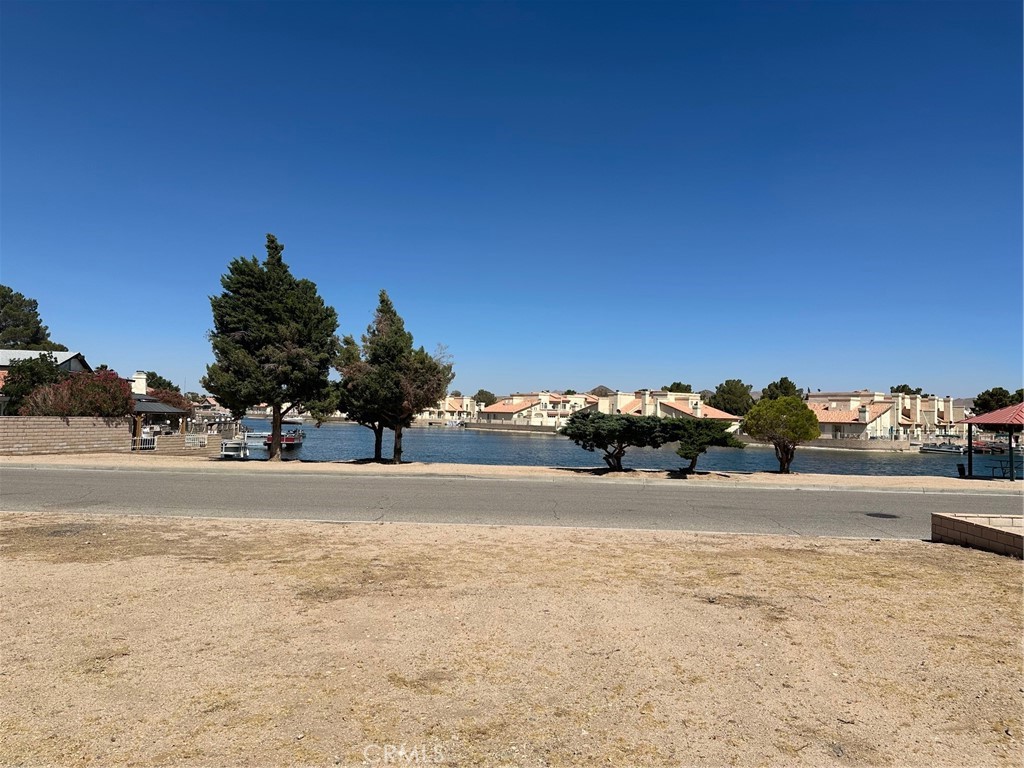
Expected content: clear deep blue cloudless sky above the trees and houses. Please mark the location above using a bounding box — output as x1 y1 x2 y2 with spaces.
0 0 1024 396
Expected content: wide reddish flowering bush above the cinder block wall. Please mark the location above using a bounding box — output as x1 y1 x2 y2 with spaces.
18 371 134 418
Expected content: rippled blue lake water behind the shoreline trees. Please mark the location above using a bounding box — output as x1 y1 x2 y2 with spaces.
244 419 1005 477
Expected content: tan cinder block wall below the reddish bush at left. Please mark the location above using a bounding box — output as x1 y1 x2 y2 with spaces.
0 416 131 456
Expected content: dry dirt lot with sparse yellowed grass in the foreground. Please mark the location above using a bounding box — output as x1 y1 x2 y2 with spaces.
0 514 1024 766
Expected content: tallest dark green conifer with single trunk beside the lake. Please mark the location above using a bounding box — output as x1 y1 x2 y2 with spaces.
202 234 338 461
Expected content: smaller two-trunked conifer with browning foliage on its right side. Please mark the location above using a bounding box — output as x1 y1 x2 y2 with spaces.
338 291 455 464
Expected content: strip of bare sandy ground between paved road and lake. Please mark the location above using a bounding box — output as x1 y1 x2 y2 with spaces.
0 453 1024 497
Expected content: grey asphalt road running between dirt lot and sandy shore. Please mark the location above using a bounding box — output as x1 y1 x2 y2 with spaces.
0 467 1021 539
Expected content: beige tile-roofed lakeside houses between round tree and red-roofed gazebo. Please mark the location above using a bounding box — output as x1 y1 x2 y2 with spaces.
807 389 966 440
